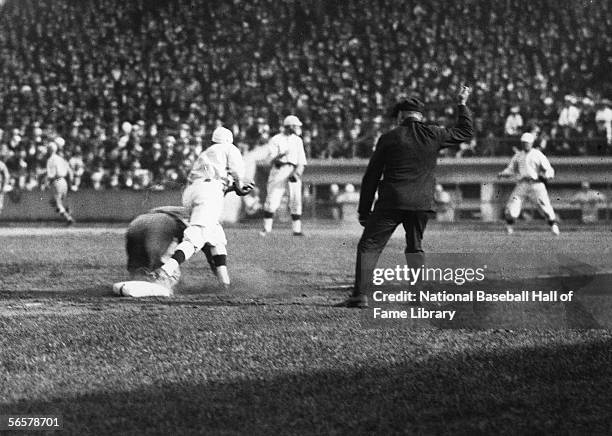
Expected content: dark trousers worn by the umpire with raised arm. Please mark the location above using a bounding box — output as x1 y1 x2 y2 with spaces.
353 208 430 296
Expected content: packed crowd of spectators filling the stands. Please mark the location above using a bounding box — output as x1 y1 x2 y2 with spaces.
0 0 612 189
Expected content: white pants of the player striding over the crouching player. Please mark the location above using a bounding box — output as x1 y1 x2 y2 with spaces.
179 179 227 255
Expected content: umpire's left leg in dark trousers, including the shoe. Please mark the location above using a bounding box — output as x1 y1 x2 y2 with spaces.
340 209 401 307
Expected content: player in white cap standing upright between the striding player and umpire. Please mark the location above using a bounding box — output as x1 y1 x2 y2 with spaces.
260 115 306 236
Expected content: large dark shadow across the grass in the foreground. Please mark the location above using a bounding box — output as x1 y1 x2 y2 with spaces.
1 334 612 435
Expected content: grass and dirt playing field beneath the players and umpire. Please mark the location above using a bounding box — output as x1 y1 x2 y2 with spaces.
0 224 612 435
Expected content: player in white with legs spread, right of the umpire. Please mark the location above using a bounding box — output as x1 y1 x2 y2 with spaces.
499 133 559 235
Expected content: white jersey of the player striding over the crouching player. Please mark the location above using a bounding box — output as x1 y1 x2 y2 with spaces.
189 143 245 182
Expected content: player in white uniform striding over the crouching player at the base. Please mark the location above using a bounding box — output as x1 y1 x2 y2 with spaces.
154 127 253 289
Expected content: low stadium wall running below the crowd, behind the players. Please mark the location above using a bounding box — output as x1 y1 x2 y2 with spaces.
0 157 612 222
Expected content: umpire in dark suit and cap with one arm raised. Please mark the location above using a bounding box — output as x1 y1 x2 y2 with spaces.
337 86 474 308
